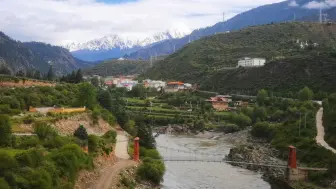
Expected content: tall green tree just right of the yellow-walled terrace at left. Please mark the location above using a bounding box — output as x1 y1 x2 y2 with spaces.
77 82 97 109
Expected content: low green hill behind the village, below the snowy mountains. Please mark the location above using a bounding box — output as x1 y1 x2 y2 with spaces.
84 60 154 76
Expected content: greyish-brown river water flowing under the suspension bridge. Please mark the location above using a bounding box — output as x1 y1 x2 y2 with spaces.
156 135 271 189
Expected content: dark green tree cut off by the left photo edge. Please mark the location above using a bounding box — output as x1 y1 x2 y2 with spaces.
0 115 12 147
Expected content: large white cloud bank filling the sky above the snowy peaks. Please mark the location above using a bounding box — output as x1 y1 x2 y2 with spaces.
0 0 282 44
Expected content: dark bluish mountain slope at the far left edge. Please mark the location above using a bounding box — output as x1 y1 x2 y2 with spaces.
0 32 90 75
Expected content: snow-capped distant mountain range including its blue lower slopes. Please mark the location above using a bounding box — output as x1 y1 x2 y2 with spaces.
65 29 190 61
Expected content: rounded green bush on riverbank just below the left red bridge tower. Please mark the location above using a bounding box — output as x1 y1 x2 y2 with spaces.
137 158 165 185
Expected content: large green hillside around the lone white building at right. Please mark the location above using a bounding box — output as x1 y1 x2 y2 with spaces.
144 22 336 94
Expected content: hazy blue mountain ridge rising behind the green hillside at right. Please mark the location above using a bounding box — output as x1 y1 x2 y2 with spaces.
125 0 336 59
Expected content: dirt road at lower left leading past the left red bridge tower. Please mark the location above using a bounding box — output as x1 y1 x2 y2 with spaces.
92 133 136 189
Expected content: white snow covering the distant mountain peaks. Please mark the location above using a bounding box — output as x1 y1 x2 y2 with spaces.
64 29 190 51
